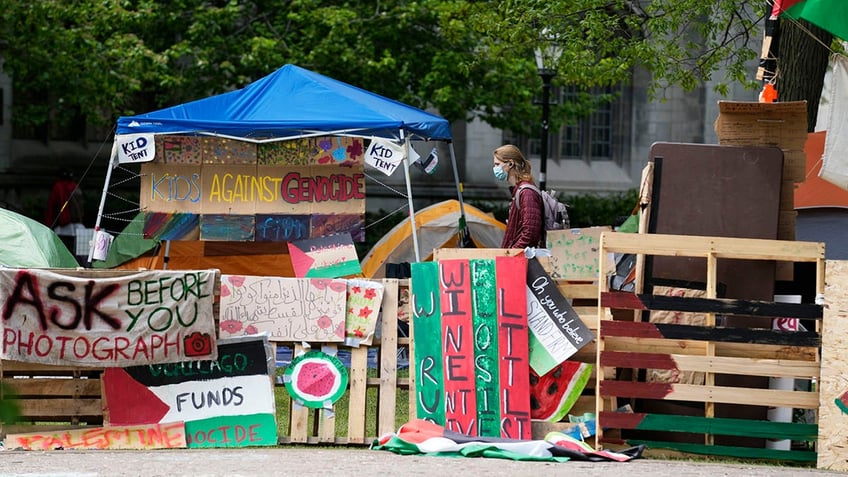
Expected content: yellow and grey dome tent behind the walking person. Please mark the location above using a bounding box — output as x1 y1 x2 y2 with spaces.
362 200 506 278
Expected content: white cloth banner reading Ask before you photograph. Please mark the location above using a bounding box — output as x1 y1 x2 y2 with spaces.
0 268 217 367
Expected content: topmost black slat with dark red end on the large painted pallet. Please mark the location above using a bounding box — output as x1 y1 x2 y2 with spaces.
601 292 822 320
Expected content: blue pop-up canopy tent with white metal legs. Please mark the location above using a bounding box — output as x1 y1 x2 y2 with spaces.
94 65 467 262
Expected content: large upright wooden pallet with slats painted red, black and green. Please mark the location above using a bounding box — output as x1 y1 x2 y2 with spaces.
596 233 825 462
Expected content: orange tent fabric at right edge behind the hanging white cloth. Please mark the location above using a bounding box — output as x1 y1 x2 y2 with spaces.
795 131 848 209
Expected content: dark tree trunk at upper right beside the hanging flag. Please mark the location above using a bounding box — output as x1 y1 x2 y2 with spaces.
777 19 833 132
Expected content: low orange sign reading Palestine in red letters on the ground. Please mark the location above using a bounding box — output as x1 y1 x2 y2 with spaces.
4 422 186 451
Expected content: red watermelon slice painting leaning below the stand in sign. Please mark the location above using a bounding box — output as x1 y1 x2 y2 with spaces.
530 360 592 422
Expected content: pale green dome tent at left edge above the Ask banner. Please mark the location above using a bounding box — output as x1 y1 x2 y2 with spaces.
0 209 79 268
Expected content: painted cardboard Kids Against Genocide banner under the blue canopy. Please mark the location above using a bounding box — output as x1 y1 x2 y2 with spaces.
140 136 365 241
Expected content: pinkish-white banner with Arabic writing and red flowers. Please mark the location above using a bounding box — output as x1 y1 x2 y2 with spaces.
220 275 347 342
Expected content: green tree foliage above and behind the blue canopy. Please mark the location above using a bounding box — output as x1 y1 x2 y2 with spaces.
0 0 764 133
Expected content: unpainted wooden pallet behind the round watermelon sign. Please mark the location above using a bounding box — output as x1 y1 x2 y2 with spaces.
277 278 414 445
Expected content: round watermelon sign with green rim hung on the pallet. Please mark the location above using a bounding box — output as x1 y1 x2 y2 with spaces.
283 351 349 409
